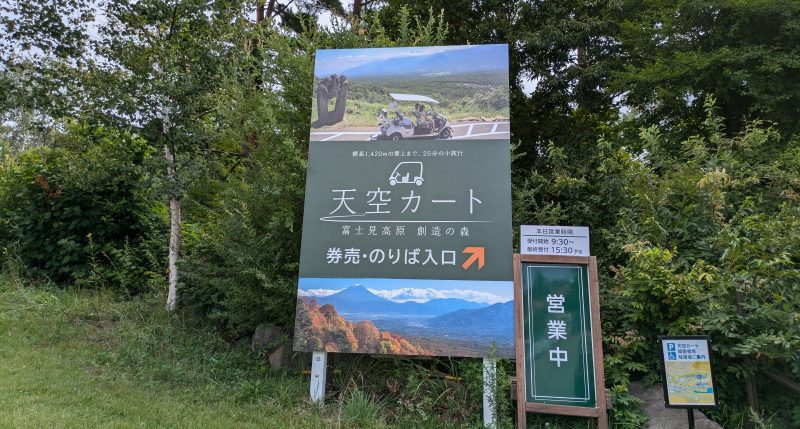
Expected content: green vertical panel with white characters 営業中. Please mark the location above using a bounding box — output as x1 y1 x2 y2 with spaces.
522 263 597 408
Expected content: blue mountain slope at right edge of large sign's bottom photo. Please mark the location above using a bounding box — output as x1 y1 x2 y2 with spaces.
426 301 514 337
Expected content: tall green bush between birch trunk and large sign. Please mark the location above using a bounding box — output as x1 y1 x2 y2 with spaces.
179 32 312 337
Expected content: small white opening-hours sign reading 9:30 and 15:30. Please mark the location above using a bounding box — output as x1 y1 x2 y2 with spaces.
519 225 590 256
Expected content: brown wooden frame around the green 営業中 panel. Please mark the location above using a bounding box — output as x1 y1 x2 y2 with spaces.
514 254 608 429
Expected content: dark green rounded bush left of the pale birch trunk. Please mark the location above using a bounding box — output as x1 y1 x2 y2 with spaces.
0 124 164 293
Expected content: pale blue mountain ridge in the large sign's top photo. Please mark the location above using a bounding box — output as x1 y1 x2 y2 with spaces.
342 45 508 78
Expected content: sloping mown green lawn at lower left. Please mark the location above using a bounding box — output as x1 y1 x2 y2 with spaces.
0 275 349 428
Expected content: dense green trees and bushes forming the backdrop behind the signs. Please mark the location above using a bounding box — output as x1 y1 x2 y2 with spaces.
0 0 800 428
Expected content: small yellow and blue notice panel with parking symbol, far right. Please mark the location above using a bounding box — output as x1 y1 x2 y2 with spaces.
658 335 717 408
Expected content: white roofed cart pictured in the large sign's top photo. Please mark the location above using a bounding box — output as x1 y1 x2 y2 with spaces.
372 94 453 141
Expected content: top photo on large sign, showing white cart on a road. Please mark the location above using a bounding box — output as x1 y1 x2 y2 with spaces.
311 45 510 141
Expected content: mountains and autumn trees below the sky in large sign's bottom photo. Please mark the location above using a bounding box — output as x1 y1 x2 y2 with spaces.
296 284 514 357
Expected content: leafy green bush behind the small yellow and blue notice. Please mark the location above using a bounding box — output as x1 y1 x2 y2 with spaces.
604 100 800 427
